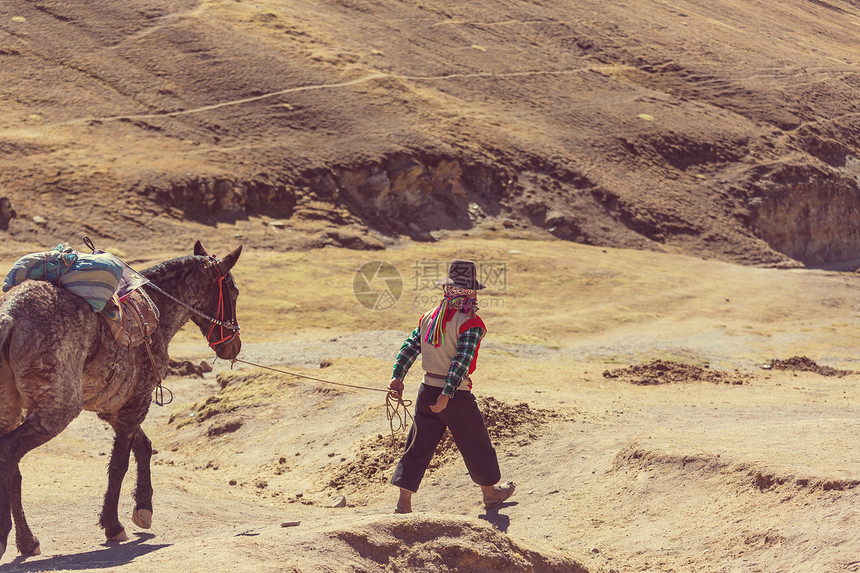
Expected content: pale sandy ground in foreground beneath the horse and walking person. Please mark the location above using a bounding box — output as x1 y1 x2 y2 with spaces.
2 318 860 573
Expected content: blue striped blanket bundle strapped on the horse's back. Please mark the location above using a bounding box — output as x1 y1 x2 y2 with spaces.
3 245 124 312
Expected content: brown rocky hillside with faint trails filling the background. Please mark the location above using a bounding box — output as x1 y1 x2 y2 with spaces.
0 0 860 266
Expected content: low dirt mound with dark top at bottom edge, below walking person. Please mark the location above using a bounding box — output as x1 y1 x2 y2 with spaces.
320 515 588 573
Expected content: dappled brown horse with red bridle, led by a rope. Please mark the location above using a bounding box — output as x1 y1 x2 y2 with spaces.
0 241 242 556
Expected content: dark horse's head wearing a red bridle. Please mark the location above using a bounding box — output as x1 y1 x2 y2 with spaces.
192 241 242 360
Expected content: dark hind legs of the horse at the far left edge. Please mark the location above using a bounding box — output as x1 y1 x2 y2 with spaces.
0 407 80 556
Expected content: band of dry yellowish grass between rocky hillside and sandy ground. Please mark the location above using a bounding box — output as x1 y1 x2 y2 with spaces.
4 238 860 363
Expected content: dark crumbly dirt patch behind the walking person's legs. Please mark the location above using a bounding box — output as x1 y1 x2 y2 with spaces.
329 397 559 490
